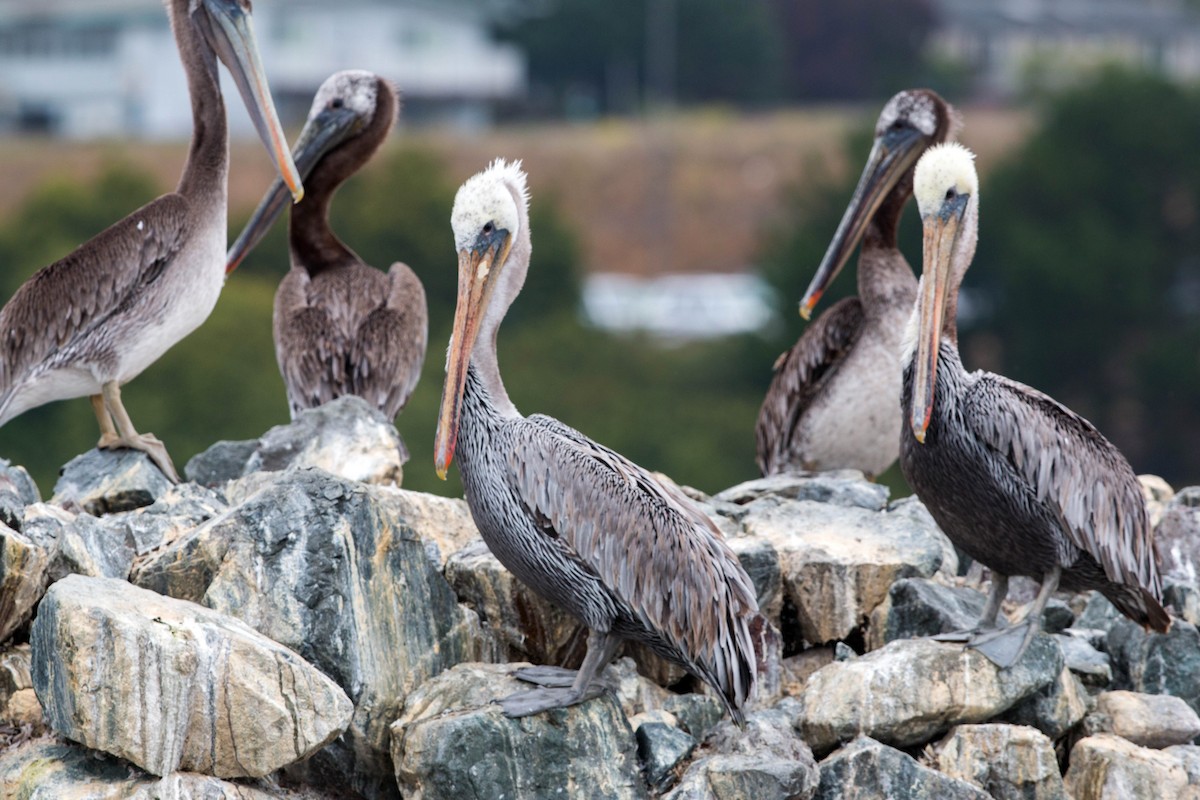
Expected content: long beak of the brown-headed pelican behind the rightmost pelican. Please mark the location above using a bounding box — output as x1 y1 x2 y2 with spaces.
800 127 925 319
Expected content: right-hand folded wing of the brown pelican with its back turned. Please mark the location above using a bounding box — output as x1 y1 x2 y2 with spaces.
350 263 430 419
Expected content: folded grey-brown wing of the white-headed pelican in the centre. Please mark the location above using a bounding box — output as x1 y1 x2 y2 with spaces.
509 415 758 705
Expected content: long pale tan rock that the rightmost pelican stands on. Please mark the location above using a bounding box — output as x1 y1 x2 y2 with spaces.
800 634 1062 753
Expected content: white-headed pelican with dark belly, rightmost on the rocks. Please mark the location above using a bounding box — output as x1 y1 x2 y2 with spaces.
900 144 1170 666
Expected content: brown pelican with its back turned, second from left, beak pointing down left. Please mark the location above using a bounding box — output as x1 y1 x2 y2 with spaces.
227 70 428 420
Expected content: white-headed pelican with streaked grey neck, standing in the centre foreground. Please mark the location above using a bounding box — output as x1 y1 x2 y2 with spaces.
434 161 758 721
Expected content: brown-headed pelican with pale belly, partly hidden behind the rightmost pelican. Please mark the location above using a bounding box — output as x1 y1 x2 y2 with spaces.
755 89 958 477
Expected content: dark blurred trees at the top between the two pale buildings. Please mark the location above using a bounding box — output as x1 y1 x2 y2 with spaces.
499 0 940 115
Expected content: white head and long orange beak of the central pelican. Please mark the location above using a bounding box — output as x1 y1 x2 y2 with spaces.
433 158 529 479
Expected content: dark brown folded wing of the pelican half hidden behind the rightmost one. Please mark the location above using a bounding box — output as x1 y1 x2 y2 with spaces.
755 297 863 475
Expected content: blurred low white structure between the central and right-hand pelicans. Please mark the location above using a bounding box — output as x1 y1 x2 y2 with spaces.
583 272 774 339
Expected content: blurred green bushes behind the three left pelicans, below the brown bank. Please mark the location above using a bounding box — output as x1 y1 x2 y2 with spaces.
0 140 774 495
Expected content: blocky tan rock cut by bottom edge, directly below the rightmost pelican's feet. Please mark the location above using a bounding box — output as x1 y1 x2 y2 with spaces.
934 724 1067 800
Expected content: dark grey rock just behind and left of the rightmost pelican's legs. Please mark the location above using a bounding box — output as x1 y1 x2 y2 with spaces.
866 578 986 650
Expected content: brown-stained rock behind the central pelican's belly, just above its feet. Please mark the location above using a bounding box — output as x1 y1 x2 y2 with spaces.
445 541 587 668
